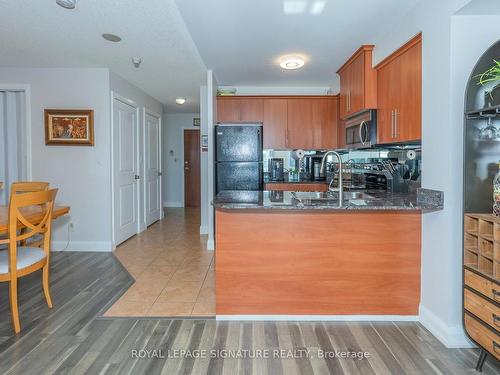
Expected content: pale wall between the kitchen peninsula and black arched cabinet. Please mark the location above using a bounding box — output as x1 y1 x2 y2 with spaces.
374 0 490 347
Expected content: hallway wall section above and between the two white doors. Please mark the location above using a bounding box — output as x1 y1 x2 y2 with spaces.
108 72 165 235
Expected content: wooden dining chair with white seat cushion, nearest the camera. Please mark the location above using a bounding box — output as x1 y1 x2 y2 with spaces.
0 189 57 333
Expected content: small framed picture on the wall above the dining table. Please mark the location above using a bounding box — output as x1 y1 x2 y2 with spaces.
45 109 94 146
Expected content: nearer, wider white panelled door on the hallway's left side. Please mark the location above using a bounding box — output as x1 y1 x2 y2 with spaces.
113 98 139 245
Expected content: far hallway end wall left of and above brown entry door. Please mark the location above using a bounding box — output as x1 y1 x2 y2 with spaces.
163 113 200 207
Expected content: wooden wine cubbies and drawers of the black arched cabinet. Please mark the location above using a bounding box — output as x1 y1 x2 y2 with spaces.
463 214 500 367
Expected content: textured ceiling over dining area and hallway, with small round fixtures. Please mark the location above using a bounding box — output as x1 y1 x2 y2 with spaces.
0 0 205 113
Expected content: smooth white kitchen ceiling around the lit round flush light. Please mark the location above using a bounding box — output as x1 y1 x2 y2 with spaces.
176 0 418 86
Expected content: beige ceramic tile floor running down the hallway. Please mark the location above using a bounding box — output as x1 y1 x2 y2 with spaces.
104 208 215 317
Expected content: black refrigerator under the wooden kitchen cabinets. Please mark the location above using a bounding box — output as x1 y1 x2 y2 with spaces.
215 124 263 193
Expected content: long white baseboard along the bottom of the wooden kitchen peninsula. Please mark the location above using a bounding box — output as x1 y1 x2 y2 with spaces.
215 315 418 322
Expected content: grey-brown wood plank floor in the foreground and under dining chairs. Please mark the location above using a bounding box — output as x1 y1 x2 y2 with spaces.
0 253 500 375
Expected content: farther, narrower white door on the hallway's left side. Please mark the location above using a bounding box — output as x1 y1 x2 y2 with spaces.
144 113 162 225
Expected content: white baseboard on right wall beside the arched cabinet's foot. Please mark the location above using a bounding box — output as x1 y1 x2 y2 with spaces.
419 305 476 349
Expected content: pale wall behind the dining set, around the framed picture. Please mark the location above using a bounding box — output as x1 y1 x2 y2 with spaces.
0 68 111 250
